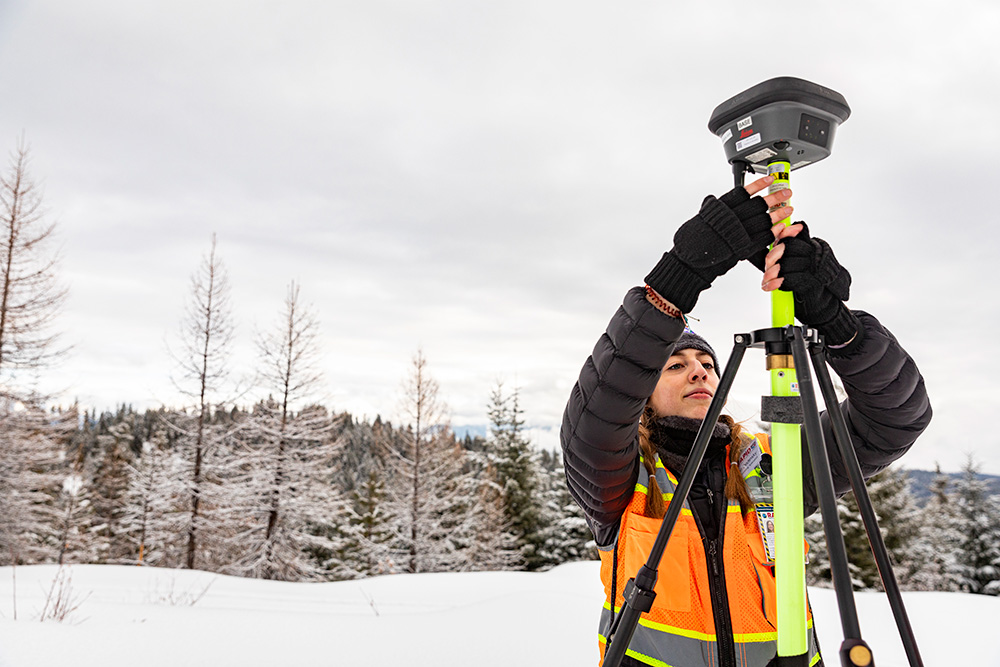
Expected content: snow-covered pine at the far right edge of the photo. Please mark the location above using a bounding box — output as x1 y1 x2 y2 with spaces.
955 456 1000 595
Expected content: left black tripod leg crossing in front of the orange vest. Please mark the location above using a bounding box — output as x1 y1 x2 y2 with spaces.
602 334 751 667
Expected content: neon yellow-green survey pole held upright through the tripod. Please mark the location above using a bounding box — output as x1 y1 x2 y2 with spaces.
767 161 809 656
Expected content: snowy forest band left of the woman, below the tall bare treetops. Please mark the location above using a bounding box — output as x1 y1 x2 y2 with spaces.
0 376 595 581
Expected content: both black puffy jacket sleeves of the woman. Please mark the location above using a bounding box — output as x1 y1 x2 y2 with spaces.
560 287 931 545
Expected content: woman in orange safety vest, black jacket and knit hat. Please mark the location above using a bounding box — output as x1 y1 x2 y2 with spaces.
561 177 931 667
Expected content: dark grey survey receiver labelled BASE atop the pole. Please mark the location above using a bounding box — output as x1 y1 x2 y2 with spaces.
708 76 851 180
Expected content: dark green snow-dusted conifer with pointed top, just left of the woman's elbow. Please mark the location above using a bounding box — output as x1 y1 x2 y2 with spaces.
484 382 555 570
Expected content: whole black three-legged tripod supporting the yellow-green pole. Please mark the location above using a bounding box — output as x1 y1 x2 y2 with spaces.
603 326 923 667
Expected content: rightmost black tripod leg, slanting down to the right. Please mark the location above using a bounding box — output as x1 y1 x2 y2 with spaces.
811 345 924 667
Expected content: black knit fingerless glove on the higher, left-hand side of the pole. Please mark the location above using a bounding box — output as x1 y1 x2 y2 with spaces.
646 188 774 313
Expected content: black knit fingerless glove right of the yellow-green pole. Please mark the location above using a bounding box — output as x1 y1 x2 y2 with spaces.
778 223 864 345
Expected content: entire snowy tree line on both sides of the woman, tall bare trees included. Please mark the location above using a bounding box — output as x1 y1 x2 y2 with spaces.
0 141 1000 595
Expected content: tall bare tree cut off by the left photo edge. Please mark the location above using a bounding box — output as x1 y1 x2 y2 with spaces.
0 139 66 564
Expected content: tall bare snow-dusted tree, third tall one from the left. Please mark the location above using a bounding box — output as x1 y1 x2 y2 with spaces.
228 282 346 581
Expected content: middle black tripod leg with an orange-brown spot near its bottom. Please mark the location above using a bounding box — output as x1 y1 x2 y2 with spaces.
790 327 872 667
